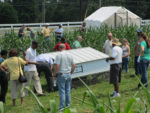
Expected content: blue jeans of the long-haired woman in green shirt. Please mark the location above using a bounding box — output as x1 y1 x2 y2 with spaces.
139 59 149 87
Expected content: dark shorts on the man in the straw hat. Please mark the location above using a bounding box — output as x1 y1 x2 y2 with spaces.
110 63 122 84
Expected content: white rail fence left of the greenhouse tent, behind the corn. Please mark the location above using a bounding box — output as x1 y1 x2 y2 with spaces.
0 22 82 36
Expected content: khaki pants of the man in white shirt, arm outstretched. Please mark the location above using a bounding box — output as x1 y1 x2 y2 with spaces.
24 71 43 96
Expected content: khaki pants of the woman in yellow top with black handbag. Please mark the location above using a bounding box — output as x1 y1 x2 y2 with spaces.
10 80 24 99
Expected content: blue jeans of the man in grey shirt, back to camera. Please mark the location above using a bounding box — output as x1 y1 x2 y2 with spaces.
57 73 72 109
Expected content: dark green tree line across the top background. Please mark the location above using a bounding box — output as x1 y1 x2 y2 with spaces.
0 0 150 24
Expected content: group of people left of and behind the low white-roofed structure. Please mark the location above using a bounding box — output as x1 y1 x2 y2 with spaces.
0 24 82 109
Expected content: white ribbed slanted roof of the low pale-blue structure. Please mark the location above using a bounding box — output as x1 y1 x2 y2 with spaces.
46 47 108 64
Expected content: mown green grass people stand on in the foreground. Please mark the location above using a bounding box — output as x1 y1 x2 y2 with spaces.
5 69 150 113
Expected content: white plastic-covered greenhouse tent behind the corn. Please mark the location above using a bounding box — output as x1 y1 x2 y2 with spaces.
85 6 141 28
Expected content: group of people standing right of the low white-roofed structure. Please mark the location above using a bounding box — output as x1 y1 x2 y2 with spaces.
103 29 150 97
